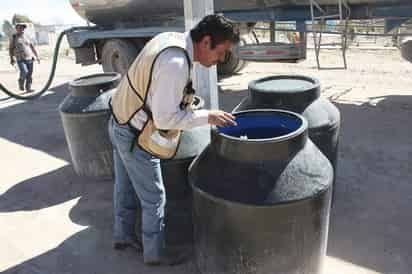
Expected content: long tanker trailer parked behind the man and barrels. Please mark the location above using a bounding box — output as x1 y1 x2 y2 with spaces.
68 0 412 74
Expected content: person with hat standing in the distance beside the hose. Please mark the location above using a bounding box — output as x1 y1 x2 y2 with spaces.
9 23 40 92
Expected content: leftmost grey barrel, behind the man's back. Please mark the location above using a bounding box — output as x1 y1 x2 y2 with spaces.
59 73 121 178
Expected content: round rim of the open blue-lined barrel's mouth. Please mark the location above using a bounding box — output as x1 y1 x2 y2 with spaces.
217 108 308 144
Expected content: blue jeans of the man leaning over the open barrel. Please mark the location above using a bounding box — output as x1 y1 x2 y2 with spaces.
109 117 166 260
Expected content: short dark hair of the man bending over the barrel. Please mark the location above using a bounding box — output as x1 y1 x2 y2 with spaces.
190 14 240 49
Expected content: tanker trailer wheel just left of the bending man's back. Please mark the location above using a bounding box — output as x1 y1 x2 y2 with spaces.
101 39 137 75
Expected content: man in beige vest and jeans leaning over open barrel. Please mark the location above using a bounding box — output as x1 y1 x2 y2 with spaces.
109 15 239 265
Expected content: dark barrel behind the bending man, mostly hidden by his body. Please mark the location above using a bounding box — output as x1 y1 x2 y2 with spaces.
136 97 210 246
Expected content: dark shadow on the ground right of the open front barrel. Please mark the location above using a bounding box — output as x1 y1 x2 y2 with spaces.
328 95 412 274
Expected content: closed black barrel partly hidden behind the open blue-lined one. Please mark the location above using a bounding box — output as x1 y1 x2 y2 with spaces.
233 75 341 201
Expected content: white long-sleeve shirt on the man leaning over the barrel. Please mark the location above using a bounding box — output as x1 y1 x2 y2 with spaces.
130 33 209 129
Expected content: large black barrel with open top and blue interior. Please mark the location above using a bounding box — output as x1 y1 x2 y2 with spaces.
189 110 333 274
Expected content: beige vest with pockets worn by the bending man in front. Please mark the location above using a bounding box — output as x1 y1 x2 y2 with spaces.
111 32 194 159
